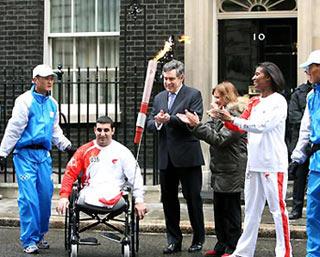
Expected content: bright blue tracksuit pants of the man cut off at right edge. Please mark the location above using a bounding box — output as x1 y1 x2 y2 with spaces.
307 170 320 257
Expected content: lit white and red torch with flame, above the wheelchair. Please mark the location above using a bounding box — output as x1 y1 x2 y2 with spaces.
134 36 174 144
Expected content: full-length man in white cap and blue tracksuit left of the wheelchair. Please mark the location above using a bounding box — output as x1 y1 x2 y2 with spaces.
0 64 72 253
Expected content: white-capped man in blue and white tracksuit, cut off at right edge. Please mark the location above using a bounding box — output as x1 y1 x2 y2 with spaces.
289 50 320 257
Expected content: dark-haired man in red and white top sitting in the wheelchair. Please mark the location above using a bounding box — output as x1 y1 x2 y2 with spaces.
56 116 147 256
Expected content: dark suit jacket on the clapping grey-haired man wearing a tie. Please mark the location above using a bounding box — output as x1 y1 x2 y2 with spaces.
147 85 204 169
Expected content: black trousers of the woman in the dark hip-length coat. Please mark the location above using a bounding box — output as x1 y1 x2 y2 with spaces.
213 192 241 254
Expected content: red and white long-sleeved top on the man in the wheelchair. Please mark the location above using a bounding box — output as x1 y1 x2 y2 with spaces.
60 140 144 203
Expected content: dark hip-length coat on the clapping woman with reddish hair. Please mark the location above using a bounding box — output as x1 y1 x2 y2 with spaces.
192 101 247 193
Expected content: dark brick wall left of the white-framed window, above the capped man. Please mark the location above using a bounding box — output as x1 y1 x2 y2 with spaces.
0 0 44 131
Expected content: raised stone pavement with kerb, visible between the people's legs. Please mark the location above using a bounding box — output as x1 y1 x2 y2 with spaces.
0 181 306 239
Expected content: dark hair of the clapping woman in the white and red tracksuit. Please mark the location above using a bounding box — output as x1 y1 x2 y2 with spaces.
257 62 285 93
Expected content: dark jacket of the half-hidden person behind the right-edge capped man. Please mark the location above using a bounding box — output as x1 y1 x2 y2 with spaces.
286 83 312 156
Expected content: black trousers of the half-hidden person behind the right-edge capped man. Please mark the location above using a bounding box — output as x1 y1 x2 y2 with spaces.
292 160 309 215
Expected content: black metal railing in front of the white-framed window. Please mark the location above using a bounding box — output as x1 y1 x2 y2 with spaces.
0 66 158 185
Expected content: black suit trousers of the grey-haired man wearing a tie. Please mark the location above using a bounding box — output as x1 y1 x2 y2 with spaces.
160 159 205 244
